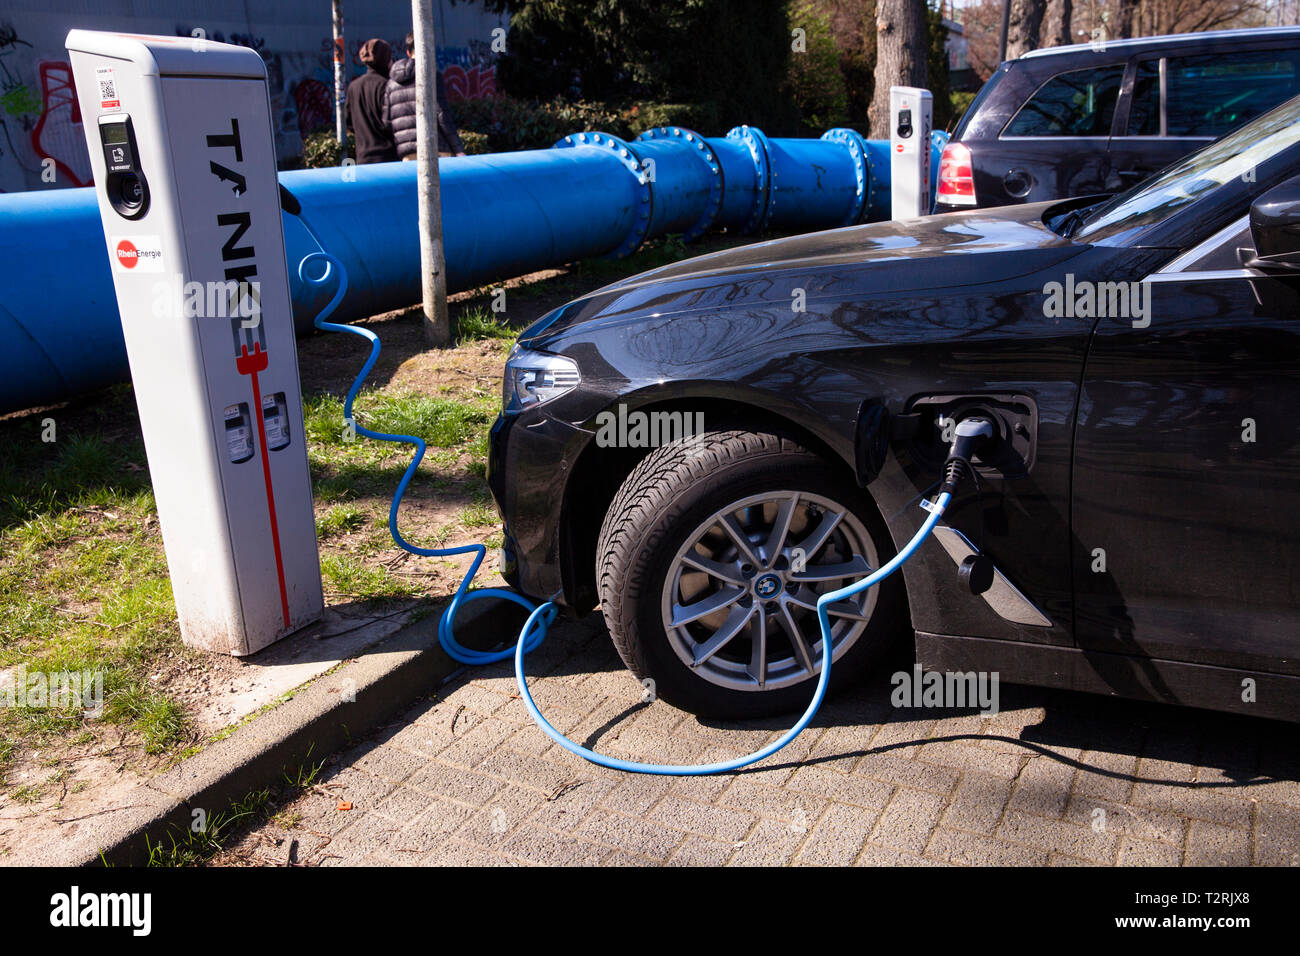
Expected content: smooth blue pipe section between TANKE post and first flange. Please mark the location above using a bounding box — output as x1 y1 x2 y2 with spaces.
280 148 642 328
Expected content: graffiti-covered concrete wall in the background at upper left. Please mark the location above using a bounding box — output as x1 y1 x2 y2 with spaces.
0 0 507 193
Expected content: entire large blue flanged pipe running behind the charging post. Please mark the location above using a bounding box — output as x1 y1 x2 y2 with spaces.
0 126 941 414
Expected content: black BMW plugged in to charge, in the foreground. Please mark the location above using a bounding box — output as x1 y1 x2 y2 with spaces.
489 99 1300 719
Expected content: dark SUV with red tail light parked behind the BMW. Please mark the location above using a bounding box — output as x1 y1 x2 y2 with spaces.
935 27 1300 212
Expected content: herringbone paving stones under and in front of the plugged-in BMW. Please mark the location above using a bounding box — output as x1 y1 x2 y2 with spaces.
218 617 1300 866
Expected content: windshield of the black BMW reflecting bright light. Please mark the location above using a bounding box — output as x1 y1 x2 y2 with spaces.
1073 96 1300 242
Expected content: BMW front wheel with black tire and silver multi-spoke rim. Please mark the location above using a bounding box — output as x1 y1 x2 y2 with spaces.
597 431 907 719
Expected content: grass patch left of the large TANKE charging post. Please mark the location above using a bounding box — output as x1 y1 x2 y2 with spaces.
0 403 185 770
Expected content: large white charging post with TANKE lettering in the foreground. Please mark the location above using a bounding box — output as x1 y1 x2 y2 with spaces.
66 30 324 656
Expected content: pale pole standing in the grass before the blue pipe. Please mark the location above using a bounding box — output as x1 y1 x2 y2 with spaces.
421 0 451 347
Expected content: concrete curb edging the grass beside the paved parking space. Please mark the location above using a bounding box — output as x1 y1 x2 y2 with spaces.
35 600 524 866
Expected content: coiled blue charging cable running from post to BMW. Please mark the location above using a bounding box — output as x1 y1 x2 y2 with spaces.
298 252 952 777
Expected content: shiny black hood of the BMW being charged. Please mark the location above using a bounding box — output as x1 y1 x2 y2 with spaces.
520 203 1087 349
